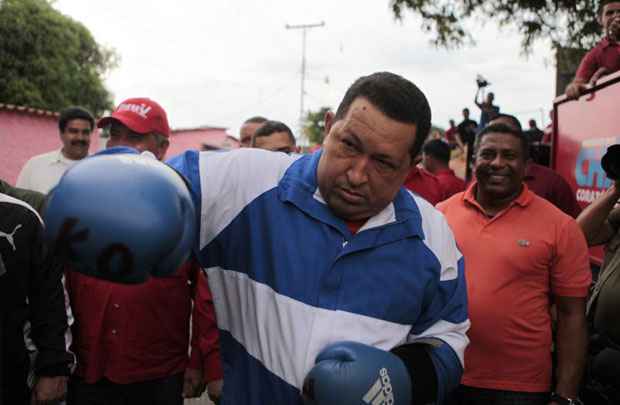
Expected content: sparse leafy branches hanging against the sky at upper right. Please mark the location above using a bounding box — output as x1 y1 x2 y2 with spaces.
390 0 601 52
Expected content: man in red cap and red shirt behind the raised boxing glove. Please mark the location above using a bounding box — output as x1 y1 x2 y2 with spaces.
67 98 222 405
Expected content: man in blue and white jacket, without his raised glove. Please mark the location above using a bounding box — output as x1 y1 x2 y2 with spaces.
169 73 469 405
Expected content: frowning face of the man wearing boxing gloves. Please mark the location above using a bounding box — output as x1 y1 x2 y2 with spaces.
317 98 416 220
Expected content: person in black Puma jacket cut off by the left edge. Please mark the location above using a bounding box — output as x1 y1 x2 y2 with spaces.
0 194 74 405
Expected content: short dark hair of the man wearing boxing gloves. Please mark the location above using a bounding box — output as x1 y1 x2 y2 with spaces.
335 72 431 158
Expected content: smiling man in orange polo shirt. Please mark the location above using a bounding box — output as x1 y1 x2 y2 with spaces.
438 124 591 405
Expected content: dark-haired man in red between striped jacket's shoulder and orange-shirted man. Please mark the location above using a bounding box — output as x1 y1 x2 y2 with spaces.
422 139 465 198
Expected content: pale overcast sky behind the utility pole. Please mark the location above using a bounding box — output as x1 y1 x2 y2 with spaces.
55 0 555 140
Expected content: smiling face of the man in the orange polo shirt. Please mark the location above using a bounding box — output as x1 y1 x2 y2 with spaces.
474 132 526 199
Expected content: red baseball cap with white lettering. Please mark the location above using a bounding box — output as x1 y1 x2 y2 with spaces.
97 98 170 138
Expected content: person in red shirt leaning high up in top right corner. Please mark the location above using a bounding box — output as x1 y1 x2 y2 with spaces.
566 0 620 98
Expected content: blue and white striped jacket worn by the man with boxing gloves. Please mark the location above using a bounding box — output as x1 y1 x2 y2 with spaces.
169 149 469 405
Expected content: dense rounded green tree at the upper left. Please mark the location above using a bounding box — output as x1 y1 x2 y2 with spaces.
0 0 118 115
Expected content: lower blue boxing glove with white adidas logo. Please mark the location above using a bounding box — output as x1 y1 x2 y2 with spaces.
303 342 412 405
